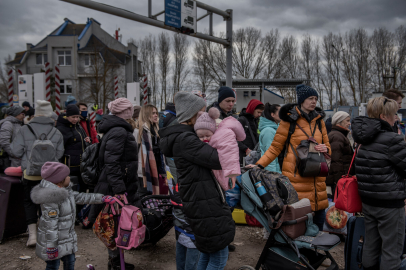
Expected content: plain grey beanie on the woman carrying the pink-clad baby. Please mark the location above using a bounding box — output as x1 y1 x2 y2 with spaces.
175 91 206 123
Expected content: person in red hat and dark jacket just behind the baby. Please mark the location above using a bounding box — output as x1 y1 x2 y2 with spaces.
238 99 265 165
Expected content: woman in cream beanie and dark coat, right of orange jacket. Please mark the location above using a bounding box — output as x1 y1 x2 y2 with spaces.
326 112 354 196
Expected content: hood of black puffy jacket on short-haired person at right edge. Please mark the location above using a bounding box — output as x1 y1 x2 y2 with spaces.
351 116 393 144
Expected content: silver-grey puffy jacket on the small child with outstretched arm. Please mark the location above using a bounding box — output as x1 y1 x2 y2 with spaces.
31 180 103 261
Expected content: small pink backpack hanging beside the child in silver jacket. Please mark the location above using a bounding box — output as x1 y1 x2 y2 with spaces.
115 196 146 249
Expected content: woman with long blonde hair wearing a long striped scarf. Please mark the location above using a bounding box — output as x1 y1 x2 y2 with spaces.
134 104 168 197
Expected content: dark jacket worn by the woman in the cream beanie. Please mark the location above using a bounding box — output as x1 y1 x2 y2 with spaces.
326 126 354 186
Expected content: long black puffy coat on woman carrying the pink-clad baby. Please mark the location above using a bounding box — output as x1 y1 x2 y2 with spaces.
159 124 235 253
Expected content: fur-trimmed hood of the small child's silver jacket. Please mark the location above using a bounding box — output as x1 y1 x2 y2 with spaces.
31 179 72 204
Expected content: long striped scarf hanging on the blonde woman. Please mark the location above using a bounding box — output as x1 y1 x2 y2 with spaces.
141 129 159 195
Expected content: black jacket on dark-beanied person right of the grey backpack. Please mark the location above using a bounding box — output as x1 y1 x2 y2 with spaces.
56 114 87 175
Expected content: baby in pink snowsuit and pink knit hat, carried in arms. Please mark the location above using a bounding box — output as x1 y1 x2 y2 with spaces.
194 108 245 191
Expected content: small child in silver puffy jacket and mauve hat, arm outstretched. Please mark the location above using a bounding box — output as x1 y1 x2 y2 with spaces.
31 162 111 270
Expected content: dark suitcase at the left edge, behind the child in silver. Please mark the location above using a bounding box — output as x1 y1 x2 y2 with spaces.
0 174 27 243
